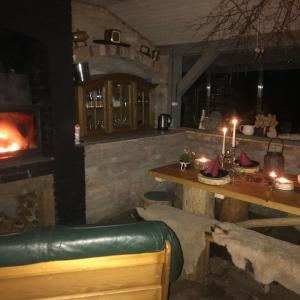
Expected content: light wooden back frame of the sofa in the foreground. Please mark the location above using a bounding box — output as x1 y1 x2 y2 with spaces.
0 241 171 300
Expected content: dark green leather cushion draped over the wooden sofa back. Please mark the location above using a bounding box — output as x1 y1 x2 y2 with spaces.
0 221 183 282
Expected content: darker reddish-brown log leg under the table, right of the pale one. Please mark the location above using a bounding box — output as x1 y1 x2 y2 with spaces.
219 198 249 223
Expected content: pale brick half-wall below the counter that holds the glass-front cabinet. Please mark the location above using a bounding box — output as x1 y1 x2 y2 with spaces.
85 133 184 223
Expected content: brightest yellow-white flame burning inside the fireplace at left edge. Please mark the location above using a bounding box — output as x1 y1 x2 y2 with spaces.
0 121 27 153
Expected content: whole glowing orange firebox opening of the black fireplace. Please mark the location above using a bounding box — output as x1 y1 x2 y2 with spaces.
0 105 40 158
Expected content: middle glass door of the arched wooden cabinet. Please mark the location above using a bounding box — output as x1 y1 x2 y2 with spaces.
112 83 131 129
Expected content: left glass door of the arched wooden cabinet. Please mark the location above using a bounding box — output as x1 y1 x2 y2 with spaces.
85 86 105 132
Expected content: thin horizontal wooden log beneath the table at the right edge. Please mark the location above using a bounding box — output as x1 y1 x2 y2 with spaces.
236 217 300 228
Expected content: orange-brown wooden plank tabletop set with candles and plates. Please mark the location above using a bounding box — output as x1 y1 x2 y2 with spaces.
149 164 300 216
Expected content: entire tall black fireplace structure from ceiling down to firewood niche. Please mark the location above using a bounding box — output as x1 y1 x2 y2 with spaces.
0 0 85 224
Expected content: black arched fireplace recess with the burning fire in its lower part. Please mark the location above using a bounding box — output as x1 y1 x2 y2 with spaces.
0 27 53 163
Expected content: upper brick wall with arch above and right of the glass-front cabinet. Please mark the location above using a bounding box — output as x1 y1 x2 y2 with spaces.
72 0 170 121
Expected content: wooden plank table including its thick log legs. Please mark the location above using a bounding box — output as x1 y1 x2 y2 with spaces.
149 163 300 281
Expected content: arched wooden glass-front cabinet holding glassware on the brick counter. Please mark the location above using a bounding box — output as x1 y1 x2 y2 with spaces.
75 74 155 138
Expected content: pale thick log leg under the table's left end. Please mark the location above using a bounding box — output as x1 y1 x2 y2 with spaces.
182 185 215 218
